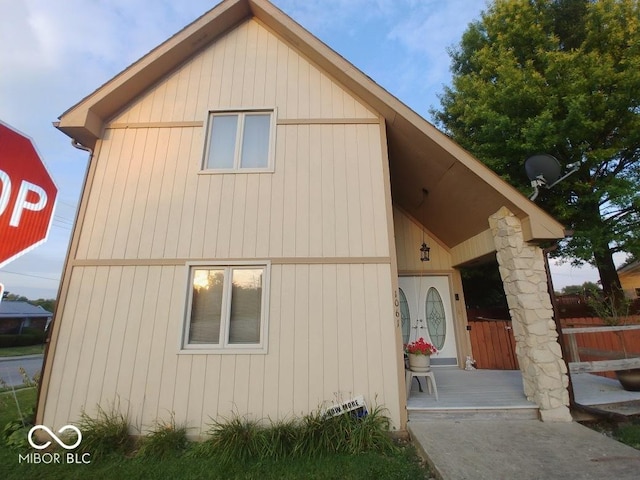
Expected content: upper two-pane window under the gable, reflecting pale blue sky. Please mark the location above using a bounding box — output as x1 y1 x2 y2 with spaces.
204 110 274 172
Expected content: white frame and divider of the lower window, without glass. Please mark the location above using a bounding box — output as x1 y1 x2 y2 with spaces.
178 260 271 355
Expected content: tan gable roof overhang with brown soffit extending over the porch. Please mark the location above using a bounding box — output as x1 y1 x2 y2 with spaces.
56 0 564 255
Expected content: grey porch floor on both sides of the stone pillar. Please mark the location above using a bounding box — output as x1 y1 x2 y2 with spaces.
407 367 640 417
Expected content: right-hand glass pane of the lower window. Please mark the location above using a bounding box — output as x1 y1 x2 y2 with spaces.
229 268 264 343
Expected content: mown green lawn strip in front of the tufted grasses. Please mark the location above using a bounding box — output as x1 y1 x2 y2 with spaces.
0 388 430 480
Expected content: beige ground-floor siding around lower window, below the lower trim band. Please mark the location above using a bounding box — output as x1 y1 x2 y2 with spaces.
45 265 398 433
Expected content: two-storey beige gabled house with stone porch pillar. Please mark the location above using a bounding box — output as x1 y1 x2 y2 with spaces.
37 0 570 433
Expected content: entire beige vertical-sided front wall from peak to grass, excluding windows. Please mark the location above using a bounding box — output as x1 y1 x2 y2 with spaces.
43 17 404 434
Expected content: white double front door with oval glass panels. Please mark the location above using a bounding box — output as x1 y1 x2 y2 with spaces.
398 276 458 366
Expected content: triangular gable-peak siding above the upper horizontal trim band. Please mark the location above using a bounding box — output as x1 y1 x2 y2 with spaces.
112 21 377 123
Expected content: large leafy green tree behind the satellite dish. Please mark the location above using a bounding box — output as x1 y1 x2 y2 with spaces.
432 0 640 300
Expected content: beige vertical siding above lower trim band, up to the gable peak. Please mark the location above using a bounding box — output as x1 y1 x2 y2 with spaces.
76 17 389 259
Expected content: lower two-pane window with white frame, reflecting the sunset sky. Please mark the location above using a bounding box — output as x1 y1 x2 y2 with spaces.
182 262 269 353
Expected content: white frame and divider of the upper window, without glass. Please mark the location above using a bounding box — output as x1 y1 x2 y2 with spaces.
200 107 277 174
